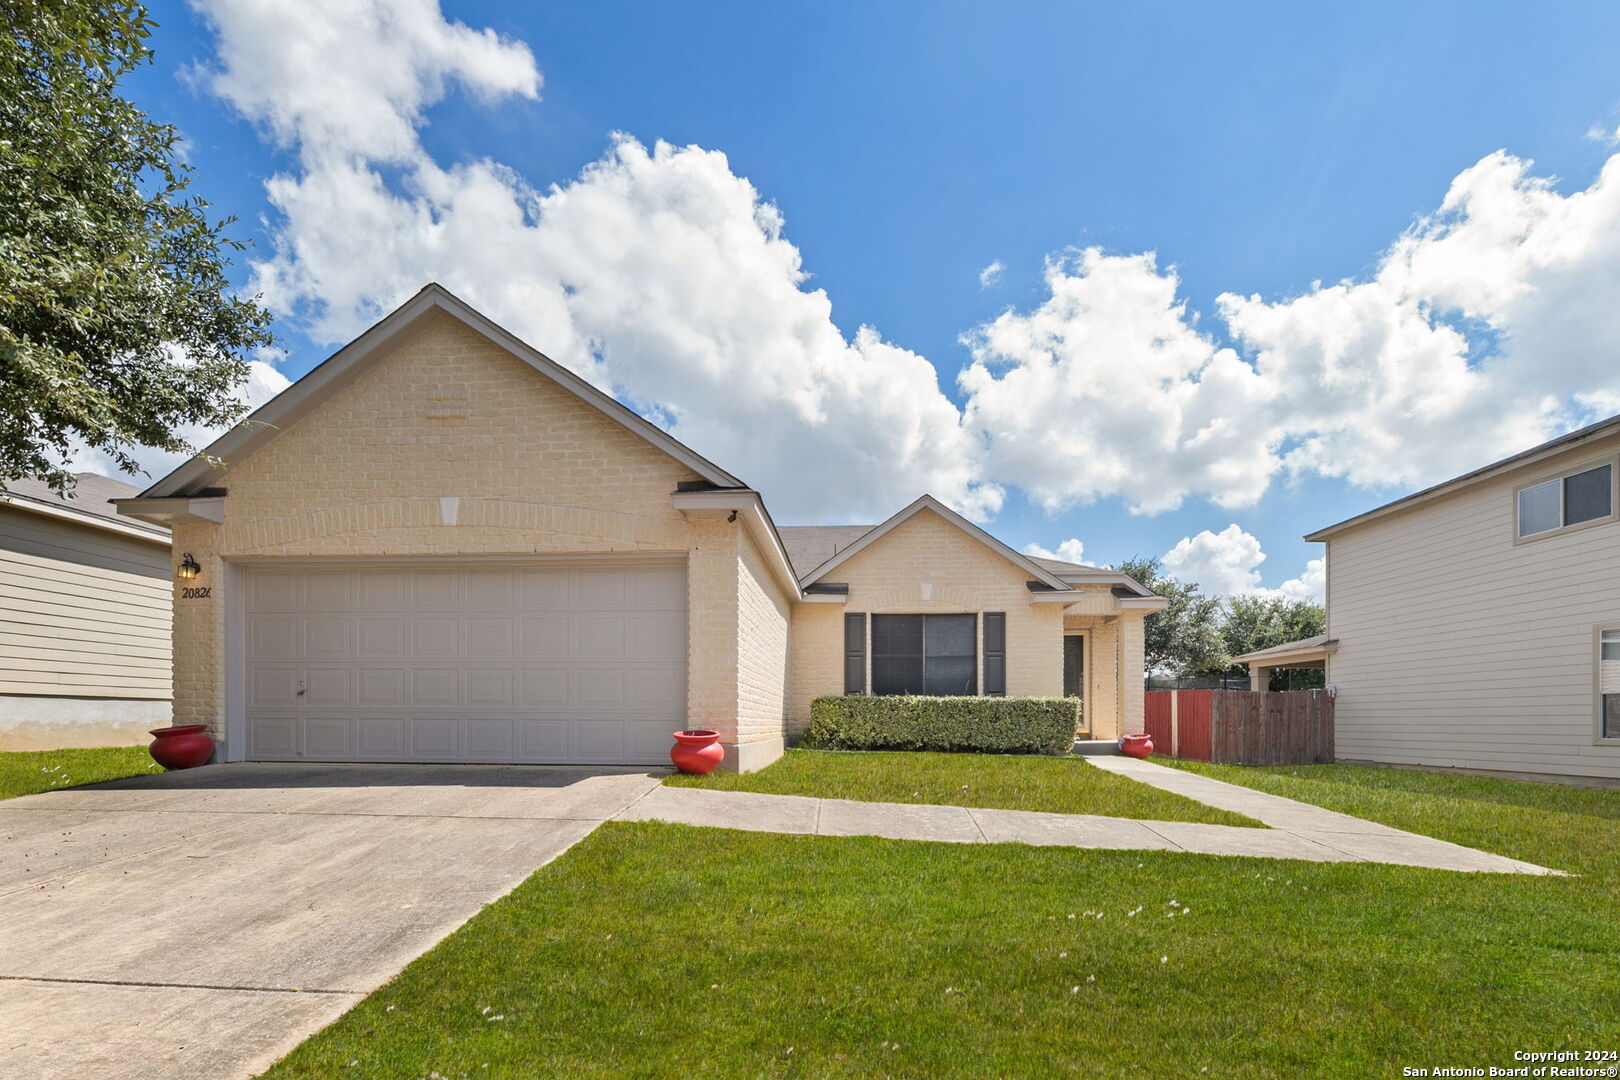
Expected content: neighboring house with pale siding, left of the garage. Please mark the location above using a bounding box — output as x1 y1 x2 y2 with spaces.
0 473 173 750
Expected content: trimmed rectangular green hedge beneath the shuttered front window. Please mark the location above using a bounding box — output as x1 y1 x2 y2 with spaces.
804 696 1079 755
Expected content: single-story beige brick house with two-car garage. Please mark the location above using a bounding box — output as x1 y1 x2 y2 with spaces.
120 285 1163 769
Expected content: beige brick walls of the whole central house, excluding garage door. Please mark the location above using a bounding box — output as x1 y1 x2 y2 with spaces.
145 291 1144 769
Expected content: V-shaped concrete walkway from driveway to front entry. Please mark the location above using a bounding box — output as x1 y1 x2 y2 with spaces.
616 756 1560 874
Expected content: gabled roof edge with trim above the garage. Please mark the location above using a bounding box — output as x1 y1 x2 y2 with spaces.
132 283 747 499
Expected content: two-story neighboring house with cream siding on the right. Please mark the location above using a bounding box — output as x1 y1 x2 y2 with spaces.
1306 416 1620 777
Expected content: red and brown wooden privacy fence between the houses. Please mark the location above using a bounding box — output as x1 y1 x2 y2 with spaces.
1144 690 1333 764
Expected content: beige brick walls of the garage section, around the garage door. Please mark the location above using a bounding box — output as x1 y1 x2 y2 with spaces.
175 314 787 767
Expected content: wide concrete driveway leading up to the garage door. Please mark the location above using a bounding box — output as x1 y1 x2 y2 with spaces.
0 764 658 1080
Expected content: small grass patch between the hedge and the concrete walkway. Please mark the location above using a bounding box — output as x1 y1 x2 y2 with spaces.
664 750 1260 827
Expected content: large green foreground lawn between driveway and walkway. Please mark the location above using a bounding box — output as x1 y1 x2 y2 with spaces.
267 792 1620 1080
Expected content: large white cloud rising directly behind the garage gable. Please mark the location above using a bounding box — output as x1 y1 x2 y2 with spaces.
189 0 1001 520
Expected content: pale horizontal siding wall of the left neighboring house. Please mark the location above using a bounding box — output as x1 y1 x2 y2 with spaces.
0 507 172 699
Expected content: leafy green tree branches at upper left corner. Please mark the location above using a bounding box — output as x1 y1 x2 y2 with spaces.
0 0 271 489
